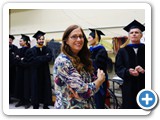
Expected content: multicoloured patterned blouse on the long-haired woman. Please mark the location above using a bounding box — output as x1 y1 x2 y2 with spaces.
53 53 96 109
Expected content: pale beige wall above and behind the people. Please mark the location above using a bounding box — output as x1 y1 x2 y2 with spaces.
10 9 145 45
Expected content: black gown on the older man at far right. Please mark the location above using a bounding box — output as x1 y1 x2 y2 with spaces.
115 44 145 109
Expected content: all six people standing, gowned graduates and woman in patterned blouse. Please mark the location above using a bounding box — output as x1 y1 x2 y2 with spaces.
9 20 145 109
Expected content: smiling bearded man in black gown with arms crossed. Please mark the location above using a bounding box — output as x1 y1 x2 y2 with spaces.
26 31 52 109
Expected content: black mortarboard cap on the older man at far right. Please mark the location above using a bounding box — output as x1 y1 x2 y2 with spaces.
123 20 145 32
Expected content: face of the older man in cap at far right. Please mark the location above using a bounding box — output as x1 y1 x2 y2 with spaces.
128 28 142 44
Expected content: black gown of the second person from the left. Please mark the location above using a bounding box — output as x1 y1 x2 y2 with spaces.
15 47 30 101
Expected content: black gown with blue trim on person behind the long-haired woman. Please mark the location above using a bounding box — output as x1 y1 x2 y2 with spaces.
90 45 108 109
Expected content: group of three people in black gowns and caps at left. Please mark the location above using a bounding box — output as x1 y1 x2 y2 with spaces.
9 31 60 109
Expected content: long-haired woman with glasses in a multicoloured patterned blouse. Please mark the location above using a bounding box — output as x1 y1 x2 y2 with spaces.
53 25 105 109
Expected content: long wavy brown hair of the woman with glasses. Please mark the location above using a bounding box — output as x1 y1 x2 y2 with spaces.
61 25 93 73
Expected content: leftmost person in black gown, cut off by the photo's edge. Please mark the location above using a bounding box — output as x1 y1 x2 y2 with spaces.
9 35 18 103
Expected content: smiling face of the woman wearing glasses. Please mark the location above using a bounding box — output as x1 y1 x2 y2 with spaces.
66 28 84 55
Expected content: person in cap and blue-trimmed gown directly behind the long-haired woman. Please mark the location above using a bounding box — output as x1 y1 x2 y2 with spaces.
88 29 108 109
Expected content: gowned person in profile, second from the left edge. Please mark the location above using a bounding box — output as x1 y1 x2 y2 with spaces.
15 34 31 109
